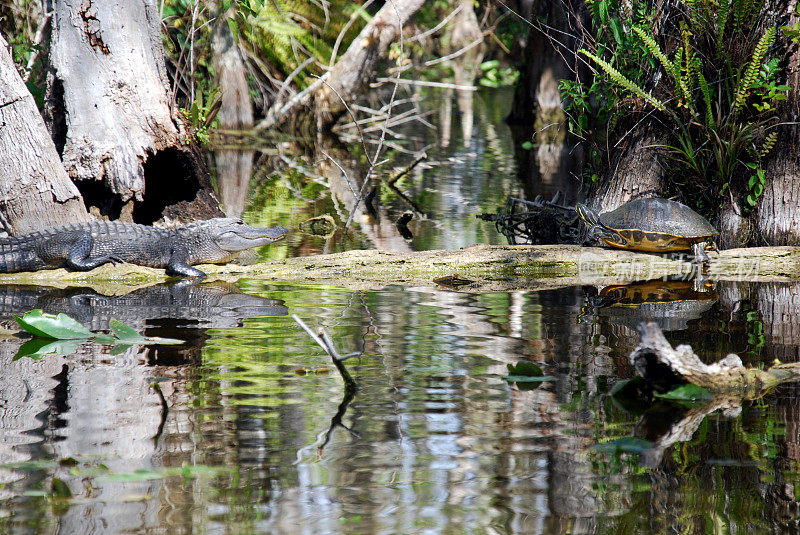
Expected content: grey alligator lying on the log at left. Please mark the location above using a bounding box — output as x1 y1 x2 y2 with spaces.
0 217 288 278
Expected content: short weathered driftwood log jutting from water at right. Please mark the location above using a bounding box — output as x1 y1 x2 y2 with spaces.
630 323 800 399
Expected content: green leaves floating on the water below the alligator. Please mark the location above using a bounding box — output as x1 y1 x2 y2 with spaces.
14 309 183 360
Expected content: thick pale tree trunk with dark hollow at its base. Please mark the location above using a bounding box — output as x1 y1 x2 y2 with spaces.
47 0 222 223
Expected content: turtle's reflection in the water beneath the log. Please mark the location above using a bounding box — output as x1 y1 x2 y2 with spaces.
584 280 719 331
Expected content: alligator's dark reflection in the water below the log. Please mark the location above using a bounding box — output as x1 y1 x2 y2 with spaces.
0 281 288 365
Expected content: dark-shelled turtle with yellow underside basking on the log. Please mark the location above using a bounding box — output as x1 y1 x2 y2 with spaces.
575 197 719 262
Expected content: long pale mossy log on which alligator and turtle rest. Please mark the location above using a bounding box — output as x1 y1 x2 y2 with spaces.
0 245 800 292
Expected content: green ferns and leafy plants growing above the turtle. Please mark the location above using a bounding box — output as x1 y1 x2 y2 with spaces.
561 0 800 214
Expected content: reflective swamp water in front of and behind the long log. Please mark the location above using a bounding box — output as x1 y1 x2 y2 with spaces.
0 88 800 534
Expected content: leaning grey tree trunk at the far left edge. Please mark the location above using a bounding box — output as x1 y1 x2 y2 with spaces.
0 33 89 234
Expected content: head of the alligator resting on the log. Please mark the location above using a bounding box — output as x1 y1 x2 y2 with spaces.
192 217 289 262
